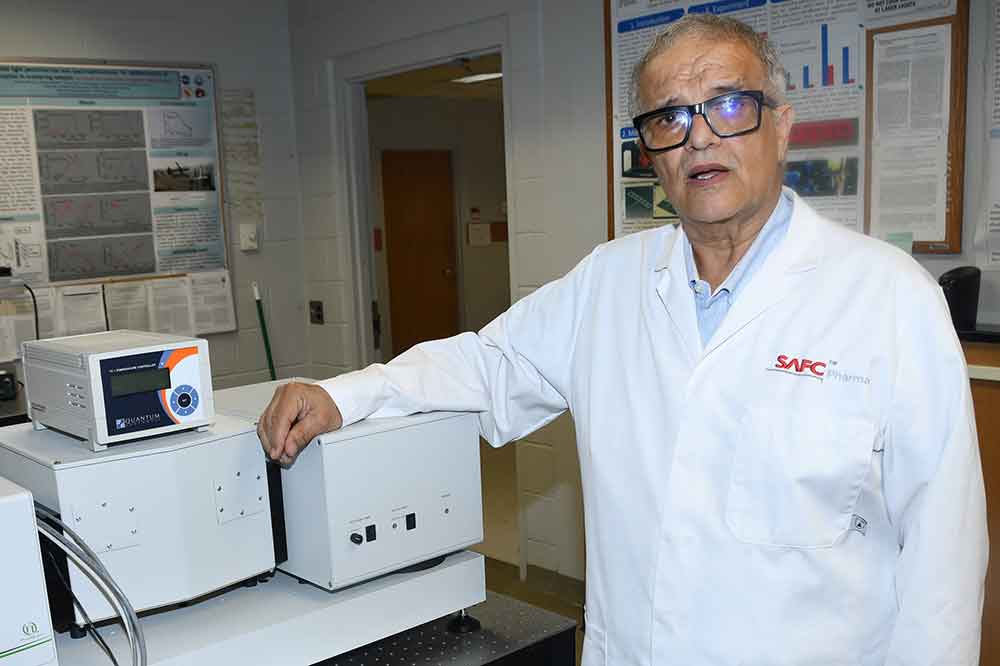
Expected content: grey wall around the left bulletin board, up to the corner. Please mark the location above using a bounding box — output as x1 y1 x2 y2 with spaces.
0 0 308 387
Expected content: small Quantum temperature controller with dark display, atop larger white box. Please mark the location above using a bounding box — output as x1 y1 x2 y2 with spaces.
23 331 215 451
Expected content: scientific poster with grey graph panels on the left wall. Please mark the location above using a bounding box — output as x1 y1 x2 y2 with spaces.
0 62 225 285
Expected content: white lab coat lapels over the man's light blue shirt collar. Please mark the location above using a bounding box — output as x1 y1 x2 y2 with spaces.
655 188 823 363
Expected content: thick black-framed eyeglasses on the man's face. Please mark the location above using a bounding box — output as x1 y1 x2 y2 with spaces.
632 90 774 153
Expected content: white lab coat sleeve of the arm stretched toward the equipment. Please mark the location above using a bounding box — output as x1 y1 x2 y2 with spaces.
321 246 594 446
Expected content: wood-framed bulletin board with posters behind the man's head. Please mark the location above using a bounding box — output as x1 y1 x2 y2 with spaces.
605 0 968 253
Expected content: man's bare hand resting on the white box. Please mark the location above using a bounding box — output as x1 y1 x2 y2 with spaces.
257 382 343 465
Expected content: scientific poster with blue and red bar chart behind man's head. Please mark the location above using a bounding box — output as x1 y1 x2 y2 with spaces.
609 0 956 236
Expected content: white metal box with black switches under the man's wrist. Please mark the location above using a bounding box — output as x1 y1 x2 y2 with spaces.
216 380 483 590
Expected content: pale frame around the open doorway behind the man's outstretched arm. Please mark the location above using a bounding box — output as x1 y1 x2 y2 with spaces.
325 15 517 367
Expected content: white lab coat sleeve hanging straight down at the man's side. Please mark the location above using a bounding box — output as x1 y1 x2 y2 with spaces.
883 268 989 666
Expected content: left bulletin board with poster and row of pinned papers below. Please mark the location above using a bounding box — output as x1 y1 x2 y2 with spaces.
0 58 239 360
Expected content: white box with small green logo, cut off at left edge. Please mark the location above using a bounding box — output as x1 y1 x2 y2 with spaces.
0 477 58 666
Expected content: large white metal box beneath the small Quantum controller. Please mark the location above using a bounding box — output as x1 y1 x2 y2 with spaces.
0 417 274 629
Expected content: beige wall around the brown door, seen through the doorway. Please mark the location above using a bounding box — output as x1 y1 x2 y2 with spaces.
368 97 510 360
